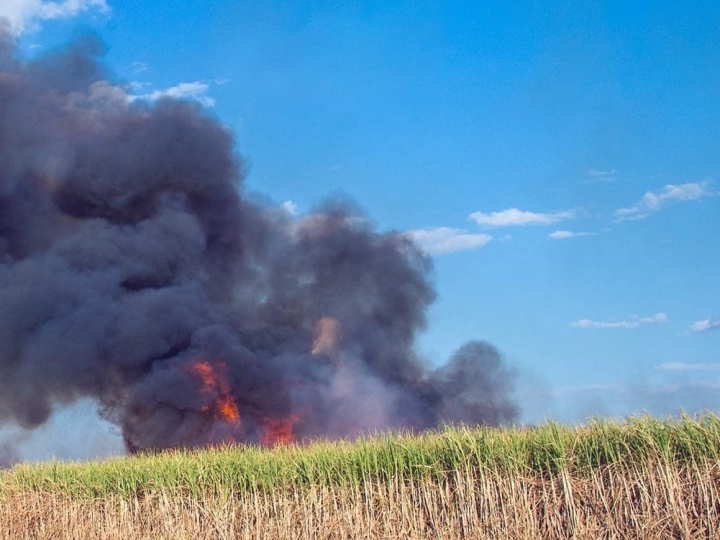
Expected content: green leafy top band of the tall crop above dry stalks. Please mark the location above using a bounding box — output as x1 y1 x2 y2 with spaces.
0 415 720 498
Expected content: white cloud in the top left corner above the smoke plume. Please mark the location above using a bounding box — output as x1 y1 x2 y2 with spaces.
0 0 110 34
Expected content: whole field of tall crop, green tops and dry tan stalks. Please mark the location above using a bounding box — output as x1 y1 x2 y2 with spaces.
0 414 720 540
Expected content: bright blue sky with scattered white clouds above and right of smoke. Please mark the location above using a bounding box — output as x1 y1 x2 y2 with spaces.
0 0 720 458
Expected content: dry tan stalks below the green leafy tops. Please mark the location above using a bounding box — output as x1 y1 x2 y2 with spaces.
0 460 720 540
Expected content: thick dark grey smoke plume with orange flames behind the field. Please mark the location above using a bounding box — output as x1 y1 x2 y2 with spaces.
0 30 518 452
